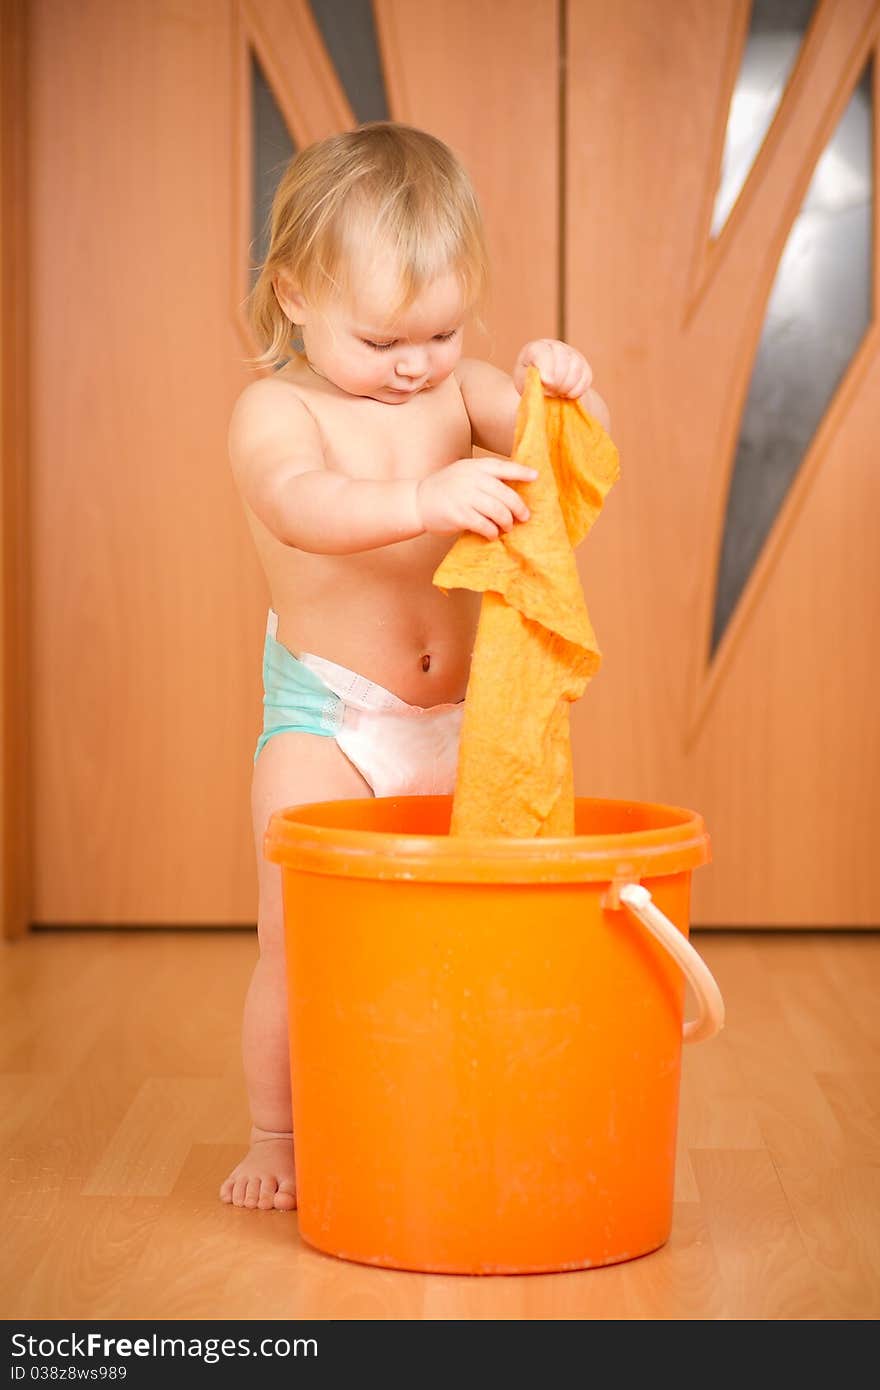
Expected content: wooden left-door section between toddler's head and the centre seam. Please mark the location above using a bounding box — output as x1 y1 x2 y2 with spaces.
374 0 559 371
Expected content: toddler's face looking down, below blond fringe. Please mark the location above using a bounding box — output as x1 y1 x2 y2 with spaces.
302 261 464 406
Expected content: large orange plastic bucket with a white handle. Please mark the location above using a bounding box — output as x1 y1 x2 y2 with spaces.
266 796 723 1275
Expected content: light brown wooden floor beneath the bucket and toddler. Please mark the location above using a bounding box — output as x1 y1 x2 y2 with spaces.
0 931 880 1321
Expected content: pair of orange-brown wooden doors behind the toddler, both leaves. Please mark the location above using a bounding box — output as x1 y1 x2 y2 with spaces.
4 0 880 926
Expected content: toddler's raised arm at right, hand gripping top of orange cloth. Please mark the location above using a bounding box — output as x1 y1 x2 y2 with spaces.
456 339 612 455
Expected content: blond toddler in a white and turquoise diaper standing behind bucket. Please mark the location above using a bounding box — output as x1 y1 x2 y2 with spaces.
220 121 609 1211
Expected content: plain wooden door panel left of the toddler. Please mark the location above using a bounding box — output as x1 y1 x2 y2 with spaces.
29 0 266 923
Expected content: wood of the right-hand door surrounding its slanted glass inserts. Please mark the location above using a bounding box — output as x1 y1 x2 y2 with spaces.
566 0 880 926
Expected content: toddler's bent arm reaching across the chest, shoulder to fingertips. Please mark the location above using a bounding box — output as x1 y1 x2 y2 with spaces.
229 377 535 555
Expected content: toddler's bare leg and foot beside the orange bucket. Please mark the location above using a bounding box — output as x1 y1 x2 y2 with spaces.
220 734 371 1211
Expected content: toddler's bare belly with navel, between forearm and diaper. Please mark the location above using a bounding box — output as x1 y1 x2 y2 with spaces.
275 559 481 708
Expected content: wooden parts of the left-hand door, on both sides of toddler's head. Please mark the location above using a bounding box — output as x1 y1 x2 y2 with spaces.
17 0 557 924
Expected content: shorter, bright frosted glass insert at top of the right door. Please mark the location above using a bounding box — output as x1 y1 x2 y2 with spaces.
712 0 816 236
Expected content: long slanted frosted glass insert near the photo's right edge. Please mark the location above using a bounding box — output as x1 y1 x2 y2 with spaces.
712 63 874 651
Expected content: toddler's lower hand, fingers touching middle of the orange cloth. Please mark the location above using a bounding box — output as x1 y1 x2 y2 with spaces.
416 457 538 541
